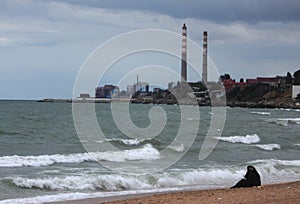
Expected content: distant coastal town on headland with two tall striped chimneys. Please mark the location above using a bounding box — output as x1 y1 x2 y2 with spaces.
40 24 300 108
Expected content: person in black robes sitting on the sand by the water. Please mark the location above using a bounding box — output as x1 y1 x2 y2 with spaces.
231 166 261 188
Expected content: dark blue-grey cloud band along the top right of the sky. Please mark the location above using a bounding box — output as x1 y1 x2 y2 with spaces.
51 0 300 23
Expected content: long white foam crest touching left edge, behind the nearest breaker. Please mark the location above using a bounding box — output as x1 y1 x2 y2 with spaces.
0 144 160 167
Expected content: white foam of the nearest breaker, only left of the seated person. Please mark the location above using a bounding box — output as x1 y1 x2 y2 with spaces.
10 168 244 191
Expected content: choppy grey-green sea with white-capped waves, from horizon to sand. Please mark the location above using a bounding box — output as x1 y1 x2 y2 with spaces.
0 100 300 204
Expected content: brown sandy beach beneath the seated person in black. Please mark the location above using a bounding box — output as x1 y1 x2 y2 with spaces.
49 181 300 204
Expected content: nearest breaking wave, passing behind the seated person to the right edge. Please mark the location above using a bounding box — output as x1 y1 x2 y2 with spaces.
6 159 300 191
